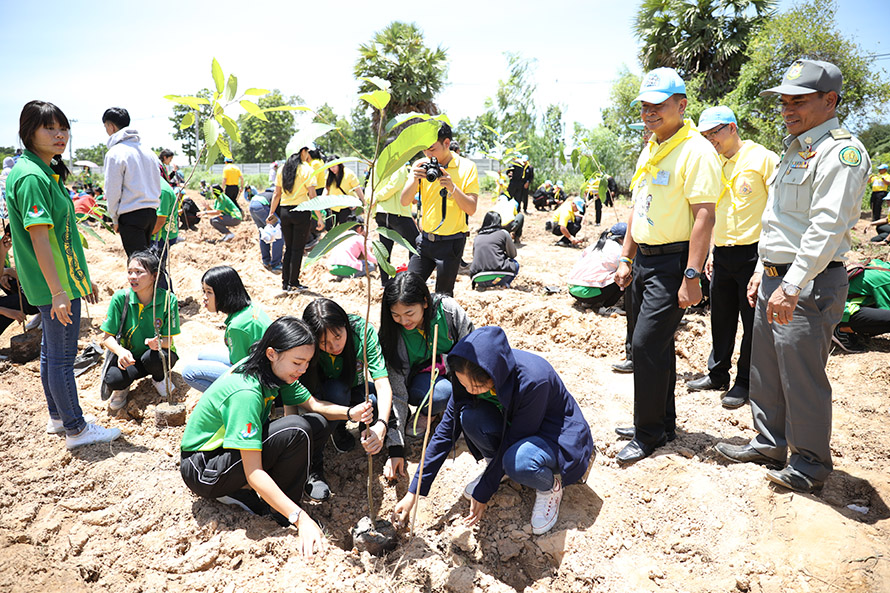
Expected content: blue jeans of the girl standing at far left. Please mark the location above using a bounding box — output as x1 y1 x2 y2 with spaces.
37 299 86 436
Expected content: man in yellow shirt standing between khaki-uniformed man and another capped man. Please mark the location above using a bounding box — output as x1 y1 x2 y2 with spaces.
686 105 779 409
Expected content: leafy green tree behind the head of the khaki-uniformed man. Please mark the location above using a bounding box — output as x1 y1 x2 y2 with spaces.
724 0 890 149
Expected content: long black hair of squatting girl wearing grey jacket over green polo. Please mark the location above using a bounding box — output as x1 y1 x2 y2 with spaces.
380 272 441 371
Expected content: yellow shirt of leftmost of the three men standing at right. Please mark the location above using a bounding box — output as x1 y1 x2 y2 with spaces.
631 120 723 245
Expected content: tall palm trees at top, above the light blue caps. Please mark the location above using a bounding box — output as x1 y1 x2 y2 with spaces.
634 0 776 101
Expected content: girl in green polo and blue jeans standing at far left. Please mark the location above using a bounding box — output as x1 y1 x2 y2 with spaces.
6 101 121 449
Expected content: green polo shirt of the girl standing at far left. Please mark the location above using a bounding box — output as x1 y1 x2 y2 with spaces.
6 150 92 306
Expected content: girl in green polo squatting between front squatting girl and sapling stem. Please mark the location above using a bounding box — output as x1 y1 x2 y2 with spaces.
301 298 392 498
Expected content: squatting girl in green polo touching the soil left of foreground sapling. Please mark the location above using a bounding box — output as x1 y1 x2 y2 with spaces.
180 316 373 556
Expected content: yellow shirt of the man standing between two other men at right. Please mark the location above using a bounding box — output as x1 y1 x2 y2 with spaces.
714 140 779 247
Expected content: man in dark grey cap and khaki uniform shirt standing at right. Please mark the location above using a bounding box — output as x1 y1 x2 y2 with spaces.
715 60 871 492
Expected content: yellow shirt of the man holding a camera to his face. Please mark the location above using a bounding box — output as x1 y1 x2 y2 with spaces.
406 152 479 236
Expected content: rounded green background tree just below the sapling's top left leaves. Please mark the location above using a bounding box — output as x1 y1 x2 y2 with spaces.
234 89 303 163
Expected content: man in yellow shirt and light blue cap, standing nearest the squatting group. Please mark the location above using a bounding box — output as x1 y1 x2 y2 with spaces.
615 68 722 463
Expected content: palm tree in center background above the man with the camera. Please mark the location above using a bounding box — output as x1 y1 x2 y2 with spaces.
354 21 448 130
